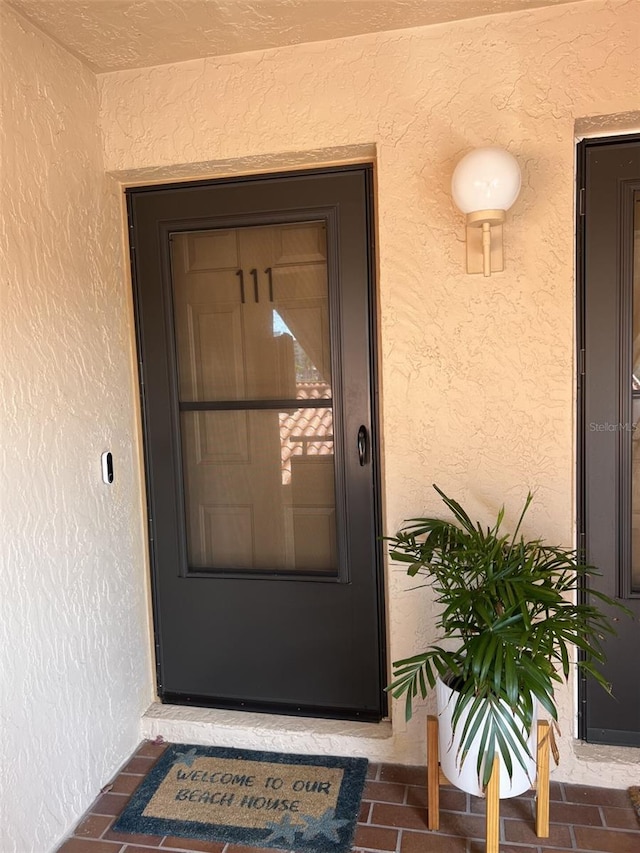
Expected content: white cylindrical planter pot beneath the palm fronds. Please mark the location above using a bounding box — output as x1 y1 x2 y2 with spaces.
436 679 537 799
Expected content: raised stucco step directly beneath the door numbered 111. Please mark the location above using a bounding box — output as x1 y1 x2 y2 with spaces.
141 702 397 763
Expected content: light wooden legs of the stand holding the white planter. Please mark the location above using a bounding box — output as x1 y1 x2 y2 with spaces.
427 715 549 853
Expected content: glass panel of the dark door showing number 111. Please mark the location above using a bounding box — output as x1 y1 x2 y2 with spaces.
171 222 337 575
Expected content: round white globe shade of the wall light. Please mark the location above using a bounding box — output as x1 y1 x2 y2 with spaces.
451 146 520 213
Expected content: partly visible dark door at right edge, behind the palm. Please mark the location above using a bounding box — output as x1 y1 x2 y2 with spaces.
579 136 640 746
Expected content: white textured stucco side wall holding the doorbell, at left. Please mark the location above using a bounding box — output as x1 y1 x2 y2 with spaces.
0 4 152 853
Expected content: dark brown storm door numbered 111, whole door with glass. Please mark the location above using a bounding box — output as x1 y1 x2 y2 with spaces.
127 166 386 720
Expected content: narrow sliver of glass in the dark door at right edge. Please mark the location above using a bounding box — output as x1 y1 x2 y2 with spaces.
631 192 640 592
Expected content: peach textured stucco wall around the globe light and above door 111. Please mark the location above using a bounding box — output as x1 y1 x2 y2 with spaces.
99 0 640 785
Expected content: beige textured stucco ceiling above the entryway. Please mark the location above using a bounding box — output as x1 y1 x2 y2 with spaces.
4 0 596 72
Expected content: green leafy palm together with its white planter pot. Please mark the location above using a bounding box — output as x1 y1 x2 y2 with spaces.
387 485 628 797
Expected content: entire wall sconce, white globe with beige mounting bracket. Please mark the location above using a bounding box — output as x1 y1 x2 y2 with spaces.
451 146 520 276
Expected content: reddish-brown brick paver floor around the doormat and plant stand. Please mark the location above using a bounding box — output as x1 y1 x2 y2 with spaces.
58 742 640 853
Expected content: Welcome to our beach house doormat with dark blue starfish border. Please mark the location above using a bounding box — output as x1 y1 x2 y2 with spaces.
113 744 367 853
